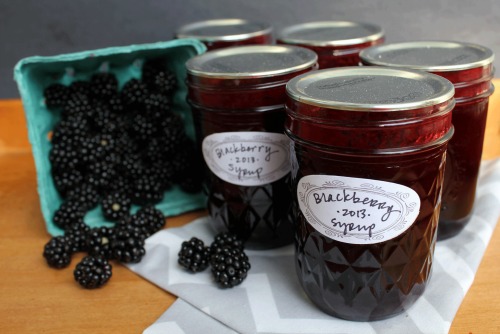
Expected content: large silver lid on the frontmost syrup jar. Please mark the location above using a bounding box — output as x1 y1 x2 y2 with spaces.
286 66 454 111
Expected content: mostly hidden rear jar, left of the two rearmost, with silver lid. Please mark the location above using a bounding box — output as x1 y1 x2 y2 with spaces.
176 19 273 50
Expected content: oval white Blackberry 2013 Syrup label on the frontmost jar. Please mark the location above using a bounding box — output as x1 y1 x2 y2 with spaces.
297 175 420 244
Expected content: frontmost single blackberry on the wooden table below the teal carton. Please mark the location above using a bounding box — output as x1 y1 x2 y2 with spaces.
73 256 112 289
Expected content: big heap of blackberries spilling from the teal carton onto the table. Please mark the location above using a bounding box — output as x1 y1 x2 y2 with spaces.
43 59 202 288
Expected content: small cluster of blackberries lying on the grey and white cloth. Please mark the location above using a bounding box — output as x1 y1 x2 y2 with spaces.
178 232 250 289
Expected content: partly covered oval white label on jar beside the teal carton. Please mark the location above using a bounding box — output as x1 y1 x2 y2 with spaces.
202 132 290 186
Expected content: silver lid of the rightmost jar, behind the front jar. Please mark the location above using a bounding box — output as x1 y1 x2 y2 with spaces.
360 41 494 72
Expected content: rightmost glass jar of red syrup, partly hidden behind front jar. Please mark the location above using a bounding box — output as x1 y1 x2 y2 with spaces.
361 41 494 240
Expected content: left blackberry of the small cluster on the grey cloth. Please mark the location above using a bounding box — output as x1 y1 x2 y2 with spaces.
177 237 210 273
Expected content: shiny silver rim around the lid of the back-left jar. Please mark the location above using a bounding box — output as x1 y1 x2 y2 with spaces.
176 18 273 42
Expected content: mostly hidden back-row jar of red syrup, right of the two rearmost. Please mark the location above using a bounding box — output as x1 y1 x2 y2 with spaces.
277 21 384 68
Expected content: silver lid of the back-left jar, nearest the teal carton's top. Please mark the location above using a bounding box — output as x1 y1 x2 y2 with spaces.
176 19 272 42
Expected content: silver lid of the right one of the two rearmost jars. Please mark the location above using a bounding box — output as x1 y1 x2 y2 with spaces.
278 21 384 46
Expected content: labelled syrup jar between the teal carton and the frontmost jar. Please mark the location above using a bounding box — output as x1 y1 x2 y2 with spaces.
186 45 317 249
